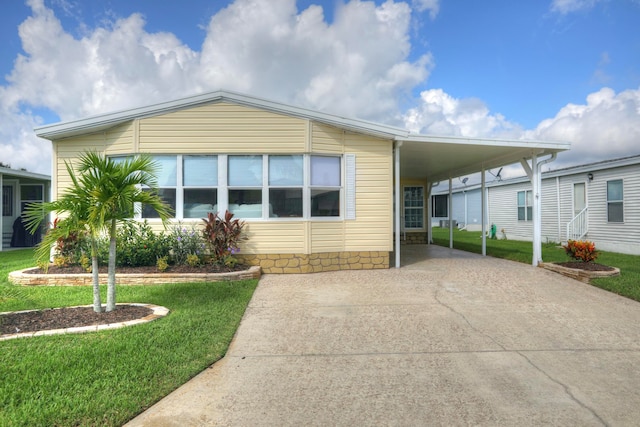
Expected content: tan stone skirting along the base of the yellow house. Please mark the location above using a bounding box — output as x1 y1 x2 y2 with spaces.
238 251 389 274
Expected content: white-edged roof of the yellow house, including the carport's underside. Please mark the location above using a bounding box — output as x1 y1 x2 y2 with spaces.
35 91 570 182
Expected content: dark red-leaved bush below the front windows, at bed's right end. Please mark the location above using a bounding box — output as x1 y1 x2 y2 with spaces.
202 211 246 265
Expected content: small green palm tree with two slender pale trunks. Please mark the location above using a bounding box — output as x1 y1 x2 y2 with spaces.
29 151 172 311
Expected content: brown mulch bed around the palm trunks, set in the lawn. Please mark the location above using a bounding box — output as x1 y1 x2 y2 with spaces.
0 304 153 335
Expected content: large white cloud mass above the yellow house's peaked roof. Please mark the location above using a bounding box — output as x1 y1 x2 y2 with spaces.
0 0 438 173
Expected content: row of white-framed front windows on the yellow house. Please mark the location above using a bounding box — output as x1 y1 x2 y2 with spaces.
132 154 342 219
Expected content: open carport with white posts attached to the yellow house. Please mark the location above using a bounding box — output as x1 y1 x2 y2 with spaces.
394 135 570 268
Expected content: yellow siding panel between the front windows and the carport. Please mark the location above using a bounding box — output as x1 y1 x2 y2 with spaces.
344 133 393 251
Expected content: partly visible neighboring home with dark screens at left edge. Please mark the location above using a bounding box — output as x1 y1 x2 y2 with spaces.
0 166 51 251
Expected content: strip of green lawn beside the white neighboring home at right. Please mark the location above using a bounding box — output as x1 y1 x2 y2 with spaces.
433 228 640 301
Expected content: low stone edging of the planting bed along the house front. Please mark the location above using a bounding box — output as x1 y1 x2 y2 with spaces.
9 266 261 286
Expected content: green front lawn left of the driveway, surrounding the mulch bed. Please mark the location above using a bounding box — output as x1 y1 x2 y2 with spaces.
0 250 257 426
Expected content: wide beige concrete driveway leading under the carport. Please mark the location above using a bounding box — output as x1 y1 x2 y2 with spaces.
128 246 640 427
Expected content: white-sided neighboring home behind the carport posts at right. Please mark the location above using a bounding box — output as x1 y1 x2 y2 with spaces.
433 156 640 255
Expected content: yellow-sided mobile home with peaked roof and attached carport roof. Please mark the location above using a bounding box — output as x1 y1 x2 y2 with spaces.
36 91 569 273
